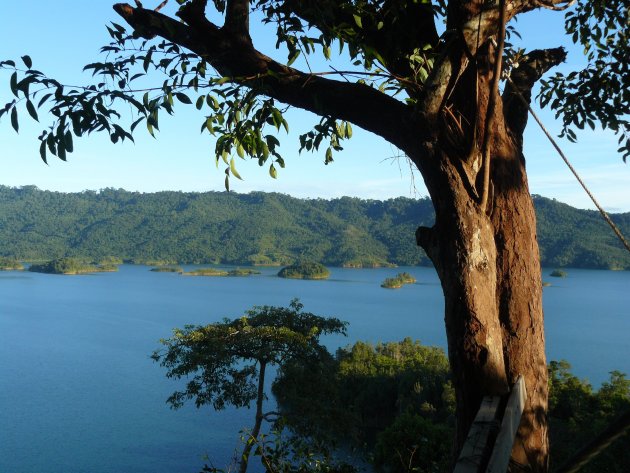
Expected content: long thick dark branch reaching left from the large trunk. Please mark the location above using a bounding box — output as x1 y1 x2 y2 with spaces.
114 2 423 150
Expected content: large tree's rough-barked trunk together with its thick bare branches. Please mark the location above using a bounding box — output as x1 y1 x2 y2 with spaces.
114 0 564 472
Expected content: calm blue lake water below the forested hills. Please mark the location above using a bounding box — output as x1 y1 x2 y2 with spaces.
0 266 630 473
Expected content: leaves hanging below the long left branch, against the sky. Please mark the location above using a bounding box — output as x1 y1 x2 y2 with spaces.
0 23 336 186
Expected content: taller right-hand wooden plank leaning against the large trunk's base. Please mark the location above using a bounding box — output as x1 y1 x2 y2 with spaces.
486 376 527 473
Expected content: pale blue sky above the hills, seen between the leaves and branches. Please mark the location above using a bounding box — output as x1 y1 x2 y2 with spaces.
0 0 630 212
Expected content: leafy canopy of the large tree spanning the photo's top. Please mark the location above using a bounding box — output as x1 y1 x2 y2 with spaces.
0 0 630 171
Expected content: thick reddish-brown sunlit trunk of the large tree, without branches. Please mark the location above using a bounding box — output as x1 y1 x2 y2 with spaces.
412 69 548 472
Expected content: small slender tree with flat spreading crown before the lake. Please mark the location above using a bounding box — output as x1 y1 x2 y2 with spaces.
151 299 347 473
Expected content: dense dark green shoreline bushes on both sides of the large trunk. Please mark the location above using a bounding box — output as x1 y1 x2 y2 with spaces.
273 338 630 473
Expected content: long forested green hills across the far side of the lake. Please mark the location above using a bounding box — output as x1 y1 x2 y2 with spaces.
0 186 630 269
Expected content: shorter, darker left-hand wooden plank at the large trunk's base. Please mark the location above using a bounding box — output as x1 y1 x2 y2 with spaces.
453 396 501 473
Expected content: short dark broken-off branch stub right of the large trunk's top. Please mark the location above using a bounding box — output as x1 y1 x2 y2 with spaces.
502 48 567 141
